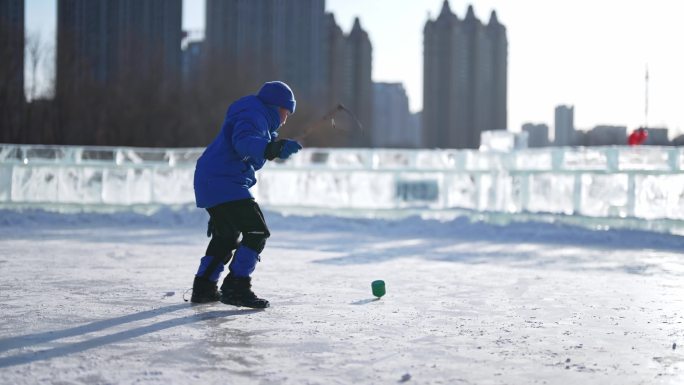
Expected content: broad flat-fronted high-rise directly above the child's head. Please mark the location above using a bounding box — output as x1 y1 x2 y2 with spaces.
205 0 329 107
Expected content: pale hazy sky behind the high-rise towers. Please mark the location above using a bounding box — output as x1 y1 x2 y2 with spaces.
26 0 684 137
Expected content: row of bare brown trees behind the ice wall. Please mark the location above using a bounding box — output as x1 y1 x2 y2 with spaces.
18 26 355 147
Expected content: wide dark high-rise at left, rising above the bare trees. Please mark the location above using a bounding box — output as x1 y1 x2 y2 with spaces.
57 0 182 96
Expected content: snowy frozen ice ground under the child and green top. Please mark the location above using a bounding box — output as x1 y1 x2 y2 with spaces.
0 210 684 384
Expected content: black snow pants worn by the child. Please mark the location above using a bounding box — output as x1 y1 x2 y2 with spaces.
199 198 271 276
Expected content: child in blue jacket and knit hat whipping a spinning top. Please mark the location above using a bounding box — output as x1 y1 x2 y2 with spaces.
191 81 302 308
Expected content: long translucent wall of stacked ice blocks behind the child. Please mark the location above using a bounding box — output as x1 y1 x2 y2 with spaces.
0 144 684 221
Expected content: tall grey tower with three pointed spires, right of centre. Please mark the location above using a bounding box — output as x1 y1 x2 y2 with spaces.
423 0 508 148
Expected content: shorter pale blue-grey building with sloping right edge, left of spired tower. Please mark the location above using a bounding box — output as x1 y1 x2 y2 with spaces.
371 83 420 148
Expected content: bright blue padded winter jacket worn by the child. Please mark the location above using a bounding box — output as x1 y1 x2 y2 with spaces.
194 95 280 208
